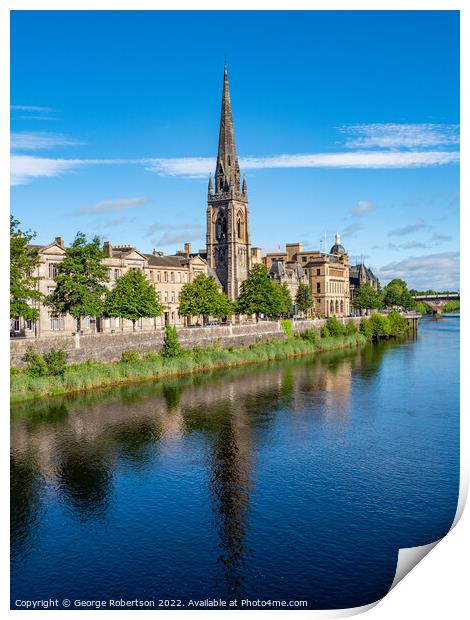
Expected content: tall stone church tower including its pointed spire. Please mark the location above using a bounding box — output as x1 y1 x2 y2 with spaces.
207 66 251 299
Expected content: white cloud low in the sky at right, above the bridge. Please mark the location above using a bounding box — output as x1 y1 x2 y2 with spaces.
378 252 459 290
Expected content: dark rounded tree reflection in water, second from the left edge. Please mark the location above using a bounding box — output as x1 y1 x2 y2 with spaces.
57 440 112 518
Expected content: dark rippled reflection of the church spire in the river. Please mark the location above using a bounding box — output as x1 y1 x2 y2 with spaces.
211 411 252 594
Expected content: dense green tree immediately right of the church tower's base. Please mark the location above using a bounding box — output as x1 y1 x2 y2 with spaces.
236 264 282 320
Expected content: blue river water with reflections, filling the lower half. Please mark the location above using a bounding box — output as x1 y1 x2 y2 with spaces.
11 316 460 609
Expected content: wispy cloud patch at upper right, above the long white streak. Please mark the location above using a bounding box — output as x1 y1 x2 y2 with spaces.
340 123 459 149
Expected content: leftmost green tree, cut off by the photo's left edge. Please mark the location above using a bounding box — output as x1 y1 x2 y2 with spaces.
10 215 43 321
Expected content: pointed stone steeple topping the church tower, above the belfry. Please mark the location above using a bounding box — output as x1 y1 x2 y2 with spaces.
215 65 240 193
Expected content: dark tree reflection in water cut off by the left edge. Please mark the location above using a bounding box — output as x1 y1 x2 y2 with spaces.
10 454 41 558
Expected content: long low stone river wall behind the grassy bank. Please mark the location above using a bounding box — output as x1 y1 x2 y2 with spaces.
10 318 360 366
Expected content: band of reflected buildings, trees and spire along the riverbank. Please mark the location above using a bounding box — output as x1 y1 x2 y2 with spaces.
11 353 358 564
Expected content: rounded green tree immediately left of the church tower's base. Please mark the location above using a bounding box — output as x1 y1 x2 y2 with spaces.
179 273 233 323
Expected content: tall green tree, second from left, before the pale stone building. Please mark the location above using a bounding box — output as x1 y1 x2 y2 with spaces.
46 232 108 331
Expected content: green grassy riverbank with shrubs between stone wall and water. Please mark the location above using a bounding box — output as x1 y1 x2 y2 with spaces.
10 313 409 402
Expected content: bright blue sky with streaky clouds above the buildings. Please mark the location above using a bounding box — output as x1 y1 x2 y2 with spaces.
11 11 460 288
